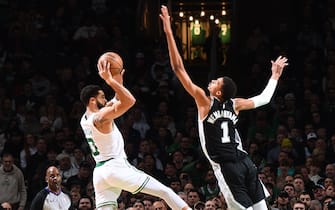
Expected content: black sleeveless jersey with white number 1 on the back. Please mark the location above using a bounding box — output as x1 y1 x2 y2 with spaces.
199 98 247 162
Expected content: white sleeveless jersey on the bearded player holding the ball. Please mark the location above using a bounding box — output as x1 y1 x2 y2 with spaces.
80 113 127 163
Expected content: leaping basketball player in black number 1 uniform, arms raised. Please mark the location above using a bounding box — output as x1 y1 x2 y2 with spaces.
160 6 288 210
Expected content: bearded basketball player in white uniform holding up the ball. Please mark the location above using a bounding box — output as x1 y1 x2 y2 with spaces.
80 58 190 210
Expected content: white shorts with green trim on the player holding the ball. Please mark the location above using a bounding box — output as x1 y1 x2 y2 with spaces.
93 158 150 208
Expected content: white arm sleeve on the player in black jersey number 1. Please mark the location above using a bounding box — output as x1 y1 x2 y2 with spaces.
249 79 278 108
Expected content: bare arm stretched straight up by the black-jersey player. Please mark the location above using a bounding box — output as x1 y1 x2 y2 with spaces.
159 5 210 108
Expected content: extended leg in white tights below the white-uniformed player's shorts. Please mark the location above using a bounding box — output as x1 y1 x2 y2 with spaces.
141 177 191 210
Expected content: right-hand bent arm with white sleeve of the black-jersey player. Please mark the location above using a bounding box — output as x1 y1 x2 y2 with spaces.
235 56 288 112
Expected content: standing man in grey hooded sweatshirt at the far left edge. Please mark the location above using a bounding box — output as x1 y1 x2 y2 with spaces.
0 153 27 210
